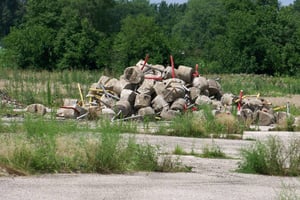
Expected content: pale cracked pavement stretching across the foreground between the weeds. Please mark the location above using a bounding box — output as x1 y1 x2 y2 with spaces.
0 135 300 200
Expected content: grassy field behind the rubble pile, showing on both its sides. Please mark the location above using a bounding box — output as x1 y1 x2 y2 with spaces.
0 67 300 107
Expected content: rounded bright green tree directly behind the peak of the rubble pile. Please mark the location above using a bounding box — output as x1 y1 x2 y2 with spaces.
113 15 170 67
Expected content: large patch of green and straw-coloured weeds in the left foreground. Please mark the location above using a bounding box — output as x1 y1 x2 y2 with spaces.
0 116 188 174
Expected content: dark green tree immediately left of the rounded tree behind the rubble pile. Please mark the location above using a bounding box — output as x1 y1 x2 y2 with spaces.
54 8 100 69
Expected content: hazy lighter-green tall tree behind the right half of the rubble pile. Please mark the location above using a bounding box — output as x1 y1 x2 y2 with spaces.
172 0 226 65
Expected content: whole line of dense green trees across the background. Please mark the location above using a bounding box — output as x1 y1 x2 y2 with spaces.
0 0 300 75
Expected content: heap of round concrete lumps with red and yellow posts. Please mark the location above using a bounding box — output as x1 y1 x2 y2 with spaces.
57 58 287 126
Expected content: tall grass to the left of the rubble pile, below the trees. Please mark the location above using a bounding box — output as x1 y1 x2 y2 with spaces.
0 67 102 107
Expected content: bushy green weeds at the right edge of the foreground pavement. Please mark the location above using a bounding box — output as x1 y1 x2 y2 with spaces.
239 137 300 176
